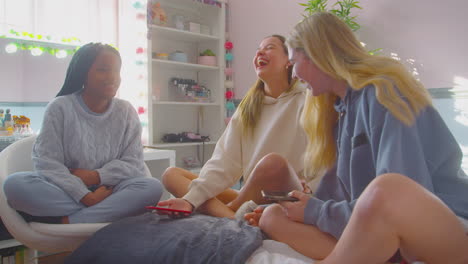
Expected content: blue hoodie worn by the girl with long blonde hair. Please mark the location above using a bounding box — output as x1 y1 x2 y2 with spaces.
304 85 468 239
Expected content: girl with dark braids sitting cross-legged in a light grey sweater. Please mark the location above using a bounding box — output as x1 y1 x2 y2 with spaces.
3 43 162 223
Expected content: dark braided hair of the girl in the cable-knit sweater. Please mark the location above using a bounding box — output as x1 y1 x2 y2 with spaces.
56 42 120 97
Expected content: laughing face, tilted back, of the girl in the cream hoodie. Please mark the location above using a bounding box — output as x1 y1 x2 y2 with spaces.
253 37 289 81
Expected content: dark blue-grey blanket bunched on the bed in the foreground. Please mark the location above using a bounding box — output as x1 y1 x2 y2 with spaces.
65 213 263 264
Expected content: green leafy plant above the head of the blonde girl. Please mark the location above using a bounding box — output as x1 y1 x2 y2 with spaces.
299 0 362 31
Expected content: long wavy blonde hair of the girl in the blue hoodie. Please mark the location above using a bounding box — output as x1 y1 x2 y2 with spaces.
287 12 431 180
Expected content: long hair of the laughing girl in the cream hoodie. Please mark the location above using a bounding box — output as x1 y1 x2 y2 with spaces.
237 35 296 136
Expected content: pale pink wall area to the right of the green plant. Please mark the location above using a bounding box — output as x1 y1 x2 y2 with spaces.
357 0 468 88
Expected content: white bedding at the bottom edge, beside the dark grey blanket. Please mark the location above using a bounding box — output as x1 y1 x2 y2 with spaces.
246 240 314 264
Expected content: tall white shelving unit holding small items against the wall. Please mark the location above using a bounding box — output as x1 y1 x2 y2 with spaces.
148 0 225 167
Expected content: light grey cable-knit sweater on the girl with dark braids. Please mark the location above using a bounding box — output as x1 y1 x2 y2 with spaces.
32 93 145 202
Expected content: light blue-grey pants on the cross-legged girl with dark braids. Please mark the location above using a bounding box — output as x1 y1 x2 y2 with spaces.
3 172 163 224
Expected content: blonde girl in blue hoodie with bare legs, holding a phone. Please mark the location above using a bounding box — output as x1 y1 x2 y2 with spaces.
246 12 468 264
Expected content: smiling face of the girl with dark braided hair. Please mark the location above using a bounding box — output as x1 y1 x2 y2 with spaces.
83 49 122 100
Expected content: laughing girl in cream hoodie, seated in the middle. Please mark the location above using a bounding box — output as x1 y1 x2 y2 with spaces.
159 35 307 217
